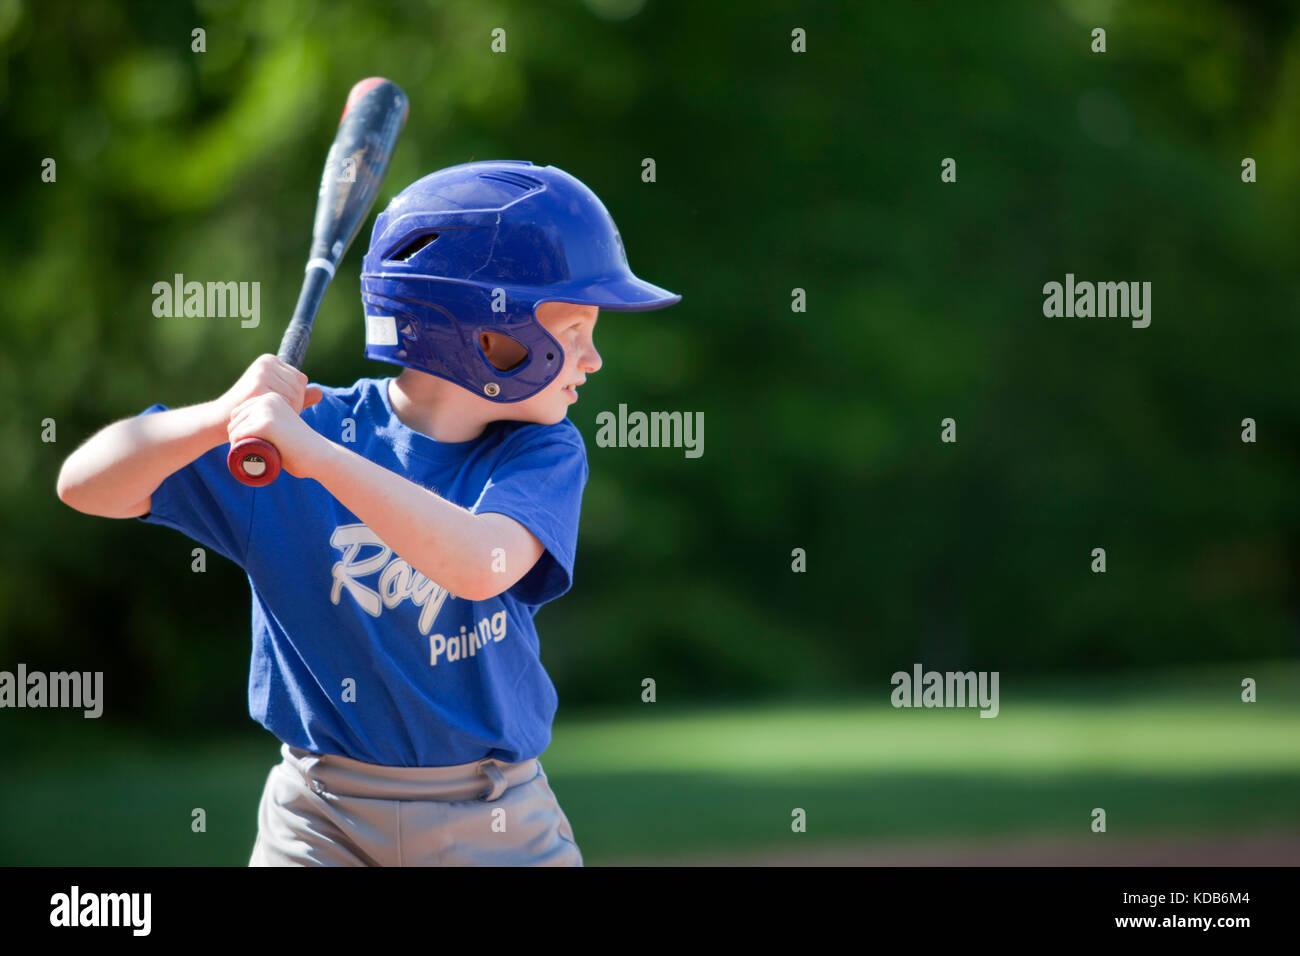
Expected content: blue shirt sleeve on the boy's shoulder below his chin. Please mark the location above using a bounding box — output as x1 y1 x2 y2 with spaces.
477 428 588 605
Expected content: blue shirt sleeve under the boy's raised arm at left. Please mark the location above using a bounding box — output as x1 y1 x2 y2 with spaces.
140 405 257 567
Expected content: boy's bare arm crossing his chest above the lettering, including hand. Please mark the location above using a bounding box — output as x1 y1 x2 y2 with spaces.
228 395 545 601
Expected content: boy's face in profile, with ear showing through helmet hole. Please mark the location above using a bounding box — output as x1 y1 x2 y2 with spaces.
482 302 601 425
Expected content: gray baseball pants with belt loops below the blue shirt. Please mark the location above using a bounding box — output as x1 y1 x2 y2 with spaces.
248 744 582 866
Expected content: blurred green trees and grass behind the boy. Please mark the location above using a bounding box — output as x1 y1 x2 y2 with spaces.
0 0 1300 864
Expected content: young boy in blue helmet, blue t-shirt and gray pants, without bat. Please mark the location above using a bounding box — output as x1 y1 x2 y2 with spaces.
59 161 680 866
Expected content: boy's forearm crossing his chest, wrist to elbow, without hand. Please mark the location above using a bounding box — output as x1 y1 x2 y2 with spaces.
311 442 491 600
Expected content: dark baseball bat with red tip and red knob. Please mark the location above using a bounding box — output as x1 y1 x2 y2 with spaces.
226 77 410 486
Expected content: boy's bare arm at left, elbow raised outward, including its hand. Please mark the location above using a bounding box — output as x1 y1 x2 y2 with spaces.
59 355 321 518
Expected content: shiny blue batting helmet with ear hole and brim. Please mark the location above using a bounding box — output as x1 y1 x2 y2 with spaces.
361 160 681 402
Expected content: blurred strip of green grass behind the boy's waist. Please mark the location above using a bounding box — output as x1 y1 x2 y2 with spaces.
0 665 1300 865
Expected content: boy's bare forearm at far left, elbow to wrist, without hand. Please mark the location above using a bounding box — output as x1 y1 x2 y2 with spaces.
59 402 226 518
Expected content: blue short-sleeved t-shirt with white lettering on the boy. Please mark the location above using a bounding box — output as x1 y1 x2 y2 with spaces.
142 378 588 766
